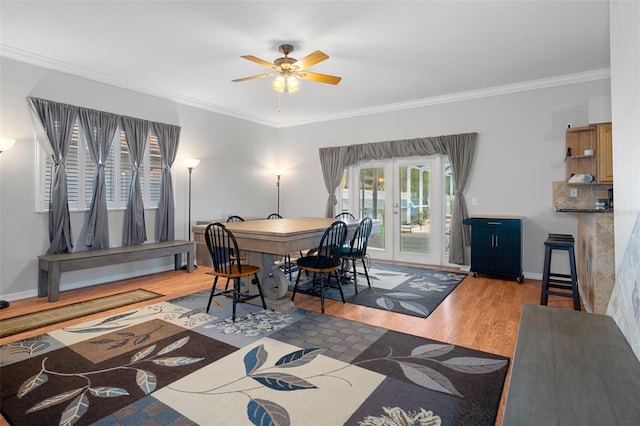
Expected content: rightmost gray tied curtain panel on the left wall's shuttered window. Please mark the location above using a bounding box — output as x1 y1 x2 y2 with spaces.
152 123 180 241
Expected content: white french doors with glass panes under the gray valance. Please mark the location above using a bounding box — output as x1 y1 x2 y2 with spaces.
341 156 454 265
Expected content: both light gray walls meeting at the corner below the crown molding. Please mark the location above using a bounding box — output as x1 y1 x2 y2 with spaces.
0 58 610 298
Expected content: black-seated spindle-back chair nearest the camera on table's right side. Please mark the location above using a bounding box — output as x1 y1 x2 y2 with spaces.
291 221 347 313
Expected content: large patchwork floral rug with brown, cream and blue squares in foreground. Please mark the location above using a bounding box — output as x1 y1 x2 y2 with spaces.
0 292 509 426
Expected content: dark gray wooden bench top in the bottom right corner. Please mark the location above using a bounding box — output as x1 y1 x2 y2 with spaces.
502 305 640 426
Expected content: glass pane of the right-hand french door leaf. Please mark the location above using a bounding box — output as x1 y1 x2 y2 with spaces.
398 164 431 254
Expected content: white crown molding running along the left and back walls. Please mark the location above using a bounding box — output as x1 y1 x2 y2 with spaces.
0 44 611 128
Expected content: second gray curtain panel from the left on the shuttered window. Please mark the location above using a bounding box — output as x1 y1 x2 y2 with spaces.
79 108 120 249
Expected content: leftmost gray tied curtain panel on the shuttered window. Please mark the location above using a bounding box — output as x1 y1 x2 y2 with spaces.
27 97 78 254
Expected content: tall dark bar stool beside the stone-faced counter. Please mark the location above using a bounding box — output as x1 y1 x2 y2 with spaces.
540 234 580 311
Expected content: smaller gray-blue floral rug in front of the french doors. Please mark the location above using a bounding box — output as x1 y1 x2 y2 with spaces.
289 262 467 318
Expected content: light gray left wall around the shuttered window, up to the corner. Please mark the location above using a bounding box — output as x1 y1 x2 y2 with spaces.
0 58 277 300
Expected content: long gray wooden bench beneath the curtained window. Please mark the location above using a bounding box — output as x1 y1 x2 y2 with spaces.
38 240 195 302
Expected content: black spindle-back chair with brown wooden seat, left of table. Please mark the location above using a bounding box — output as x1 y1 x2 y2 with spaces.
205 222 267 322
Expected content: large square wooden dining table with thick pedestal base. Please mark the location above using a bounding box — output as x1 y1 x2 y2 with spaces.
192 217 360 312
